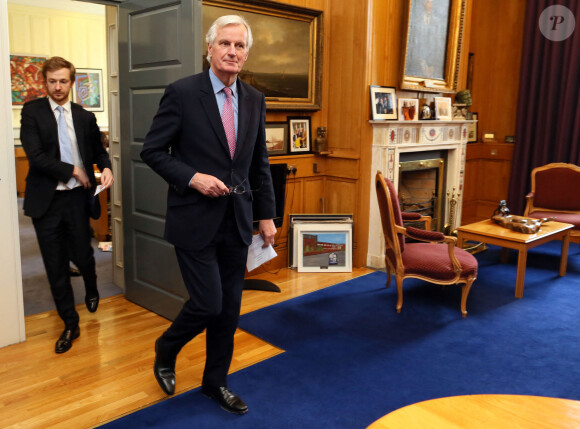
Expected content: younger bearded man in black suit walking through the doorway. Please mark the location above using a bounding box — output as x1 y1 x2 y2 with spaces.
20 57 113 353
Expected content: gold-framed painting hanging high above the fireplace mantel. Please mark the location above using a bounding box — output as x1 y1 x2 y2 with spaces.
401 0 466 93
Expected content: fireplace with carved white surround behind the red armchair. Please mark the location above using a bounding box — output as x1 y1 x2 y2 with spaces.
367 120 473 268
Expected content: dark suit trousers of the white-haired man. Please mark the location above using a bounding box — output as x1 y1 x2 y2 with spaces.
159 196 248 388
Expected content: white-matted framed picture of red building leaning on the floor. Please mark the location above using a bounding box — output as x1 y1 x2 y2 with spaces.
294 223 352 273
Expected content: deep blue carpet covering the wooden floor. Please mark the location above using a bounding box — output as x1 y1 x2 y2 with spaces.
105 242 580 429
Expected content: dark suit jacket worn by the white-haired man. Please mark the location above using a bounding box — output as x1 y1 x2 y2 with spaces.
141 71 275 250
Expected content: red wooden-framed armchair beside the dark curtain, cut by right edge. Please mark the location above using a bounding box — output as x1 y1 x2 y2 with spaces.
524 162 580 243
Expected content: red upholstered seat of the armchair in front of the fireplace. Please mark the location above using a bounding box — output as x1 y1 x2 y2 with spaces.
402 243 477 281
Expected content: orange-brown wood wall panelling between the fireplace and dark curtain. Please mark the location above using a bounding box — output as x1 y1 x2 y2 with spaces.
462 0 526 224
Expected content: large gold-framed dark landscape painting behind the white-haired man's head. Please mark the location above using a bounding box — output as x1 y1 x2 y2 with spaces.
202 0 323 110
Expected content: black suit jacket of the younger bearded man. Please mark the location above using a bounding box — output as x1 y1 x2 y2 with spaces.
20 98 111 218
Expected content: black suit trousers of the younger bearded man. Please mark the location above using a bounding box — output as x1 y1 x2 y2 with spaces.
32 187 98 329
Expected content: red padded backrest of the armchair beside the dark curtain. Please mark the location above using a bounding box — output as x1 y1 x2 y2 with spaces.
534 168 580 211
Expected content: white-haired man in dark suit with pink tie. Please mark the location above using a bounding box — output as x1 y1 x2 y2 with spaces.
141 15 276 414
